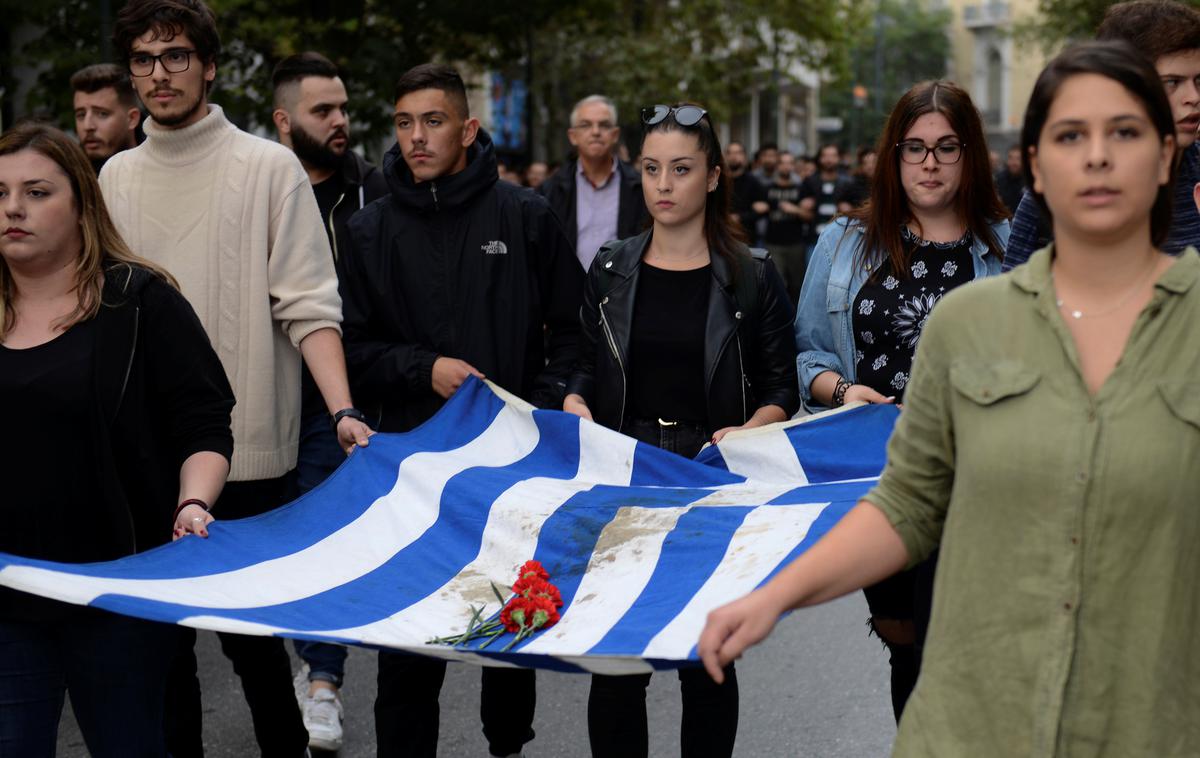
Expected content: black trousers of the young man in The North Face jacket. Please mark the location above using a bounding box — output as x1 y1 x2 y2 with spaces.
374 650 538 758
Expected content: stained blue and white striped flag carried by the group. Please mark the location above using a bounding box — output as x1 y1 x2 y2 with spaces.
0 379 898 674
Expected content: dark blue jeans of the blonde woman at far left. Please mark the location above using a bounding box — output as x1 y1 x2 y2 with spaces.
0 601 175 758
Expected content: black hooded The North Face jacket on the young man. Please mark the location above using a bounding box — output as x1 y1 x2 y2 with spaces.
338 130 583 432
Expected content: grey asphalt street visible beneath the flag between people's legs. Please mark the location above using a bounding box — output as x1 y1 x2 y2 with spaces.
59 594 895 758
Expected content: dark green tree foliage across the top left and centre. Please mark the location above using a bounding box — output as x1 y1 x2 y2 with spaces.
7 0 851 156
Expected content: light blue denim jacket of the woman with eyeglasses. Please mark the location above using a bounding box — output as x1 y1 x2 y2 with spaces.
796 217 1009 408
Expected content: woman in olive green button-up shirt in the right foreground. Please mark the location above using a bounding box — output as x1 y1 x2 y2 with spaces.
700 42 1200 758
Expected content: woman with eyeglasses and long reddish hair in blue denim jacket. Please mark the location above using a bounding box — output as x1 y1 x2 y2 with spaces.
796 82 1008 720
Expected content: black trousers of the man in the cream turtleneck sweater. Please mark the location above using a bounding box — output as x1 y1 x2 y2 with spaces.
166 476 308 758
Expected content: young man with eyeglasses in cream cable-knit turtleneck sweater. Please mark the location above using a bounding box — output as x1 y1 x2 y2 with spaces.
100 0 370 758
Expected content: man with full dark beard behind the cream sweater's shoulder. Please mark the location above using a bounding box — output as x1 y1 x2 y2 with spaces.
271 52 388 752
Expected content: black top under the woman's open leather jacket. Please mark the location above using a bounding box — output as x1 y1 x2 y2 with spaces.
626 263 713 428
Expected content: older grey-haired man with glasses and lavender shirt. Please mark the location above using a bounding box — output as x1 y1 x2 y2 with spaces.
538 95 649 271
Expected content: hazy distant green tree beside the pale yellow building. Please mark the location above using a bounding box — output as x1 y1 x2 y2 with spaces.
821 0 953 150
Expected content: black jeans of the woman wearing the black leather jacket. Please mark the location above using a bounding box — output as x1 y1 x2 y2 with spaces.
588 420 738 758
